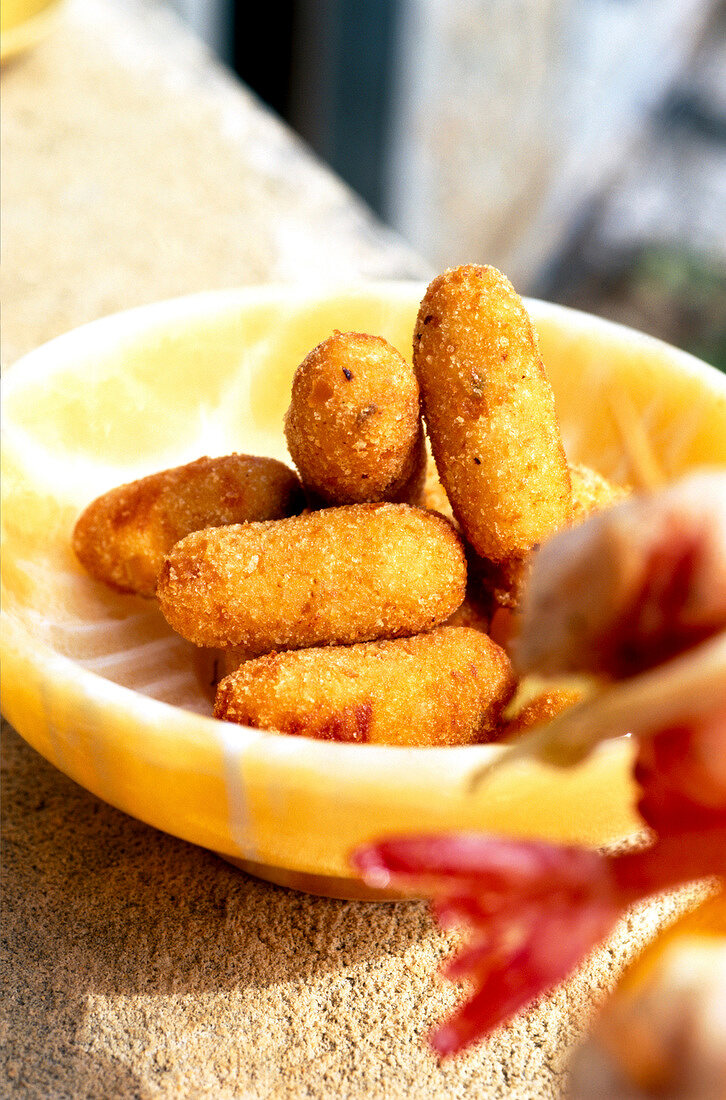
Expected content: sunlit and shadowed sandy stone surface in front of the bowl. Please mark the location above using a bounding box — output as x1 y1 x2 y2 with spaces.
2 728 708 1100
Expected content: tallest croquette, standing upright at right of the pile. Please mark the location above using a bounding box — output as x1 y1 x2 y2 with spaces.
414 265 572 585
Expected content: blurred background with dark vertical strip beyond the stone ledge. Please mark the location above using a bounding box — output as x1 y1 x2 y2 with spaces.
172 0 726 370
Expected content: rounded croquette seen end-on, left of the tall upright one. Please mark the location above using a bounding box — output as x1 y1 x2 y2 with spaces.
285 331 426 505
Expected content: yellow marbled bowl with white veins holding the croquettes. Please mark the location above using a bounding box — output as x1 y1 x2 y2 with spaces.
2 283 726 897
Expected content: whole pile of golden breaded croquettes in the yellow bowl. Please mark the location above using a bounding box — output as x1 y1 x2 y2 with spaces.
73 265 626 746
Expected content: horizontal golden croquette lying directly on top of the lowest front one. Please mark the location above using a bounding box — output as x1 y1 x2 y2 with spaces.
156 504 466 650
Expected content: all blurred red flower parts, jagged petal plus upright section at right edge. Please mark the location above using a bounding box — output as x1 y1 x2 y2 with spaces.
352 710 726 1055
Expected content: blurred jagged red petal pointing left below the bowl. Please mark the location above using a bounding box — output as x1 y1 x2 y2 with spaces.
353 826 726 1055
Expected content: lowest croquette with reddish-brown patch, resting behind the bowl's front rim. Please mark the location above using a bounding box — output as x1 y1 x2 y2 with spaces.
215 627 514 746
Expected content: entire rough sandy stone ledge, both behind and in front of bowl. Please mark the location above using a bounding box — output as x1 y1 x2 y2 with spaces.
0 0 708 1100
